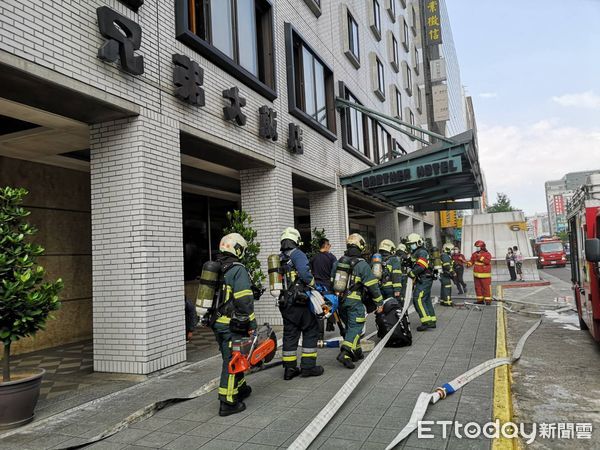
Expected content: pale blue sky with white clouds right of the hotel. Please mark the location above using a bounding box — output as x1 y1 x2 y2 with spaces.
446 0 600 215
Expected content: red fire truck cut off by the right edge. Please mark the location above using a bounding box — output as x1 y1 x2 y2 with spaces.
567 174 600 342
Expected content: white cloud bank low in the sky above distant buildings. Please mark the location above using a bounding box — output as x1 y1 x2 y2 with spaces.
478 120 600 214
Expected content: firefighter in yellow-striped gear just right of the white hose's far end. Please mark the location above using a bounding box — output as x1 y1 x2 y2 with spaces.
406 233 437 331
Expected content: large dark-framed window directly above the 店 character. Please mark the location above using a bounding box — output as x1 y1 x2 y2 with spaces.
285 23 336 141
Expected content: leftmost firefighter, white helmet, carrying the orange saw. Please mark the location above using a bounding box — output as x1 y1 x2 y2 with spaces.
212 233 256 416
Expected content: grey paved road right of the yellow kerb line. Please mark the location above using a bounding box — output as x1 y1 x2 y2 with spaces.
505 266 600 449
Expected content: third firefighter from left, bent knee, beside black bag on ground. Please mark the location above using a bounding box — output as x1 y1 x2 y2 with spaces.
332 233 383 369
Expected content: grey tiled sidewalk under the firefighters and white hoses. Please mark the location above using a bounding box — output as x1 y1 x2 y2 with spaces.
0 298 496 450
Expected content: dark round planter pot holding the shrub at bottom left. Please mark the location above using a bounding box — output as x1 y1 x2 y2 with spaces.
0 369 46 430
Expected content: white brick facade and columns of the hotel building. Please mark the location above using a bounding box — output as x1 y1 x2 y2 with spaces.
0 0 436 373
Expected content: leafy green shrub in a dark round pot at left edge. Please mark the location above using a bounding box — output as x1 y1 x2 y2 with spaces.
0 187 63 429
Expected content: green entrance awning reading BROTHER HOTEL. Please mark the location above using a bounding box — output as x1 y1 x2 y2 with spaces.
340 131 483 210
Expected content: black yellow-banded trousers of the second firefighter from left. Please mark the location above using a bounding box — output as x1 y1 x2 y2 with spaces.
280 305 320 369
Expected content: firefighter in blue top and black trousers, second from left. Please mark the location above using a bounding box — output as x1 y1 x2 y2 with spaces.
279 227 324 380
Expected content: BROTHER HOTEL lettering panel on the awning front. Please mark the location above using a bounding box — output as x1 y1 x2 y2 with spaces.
362 156 462 189
